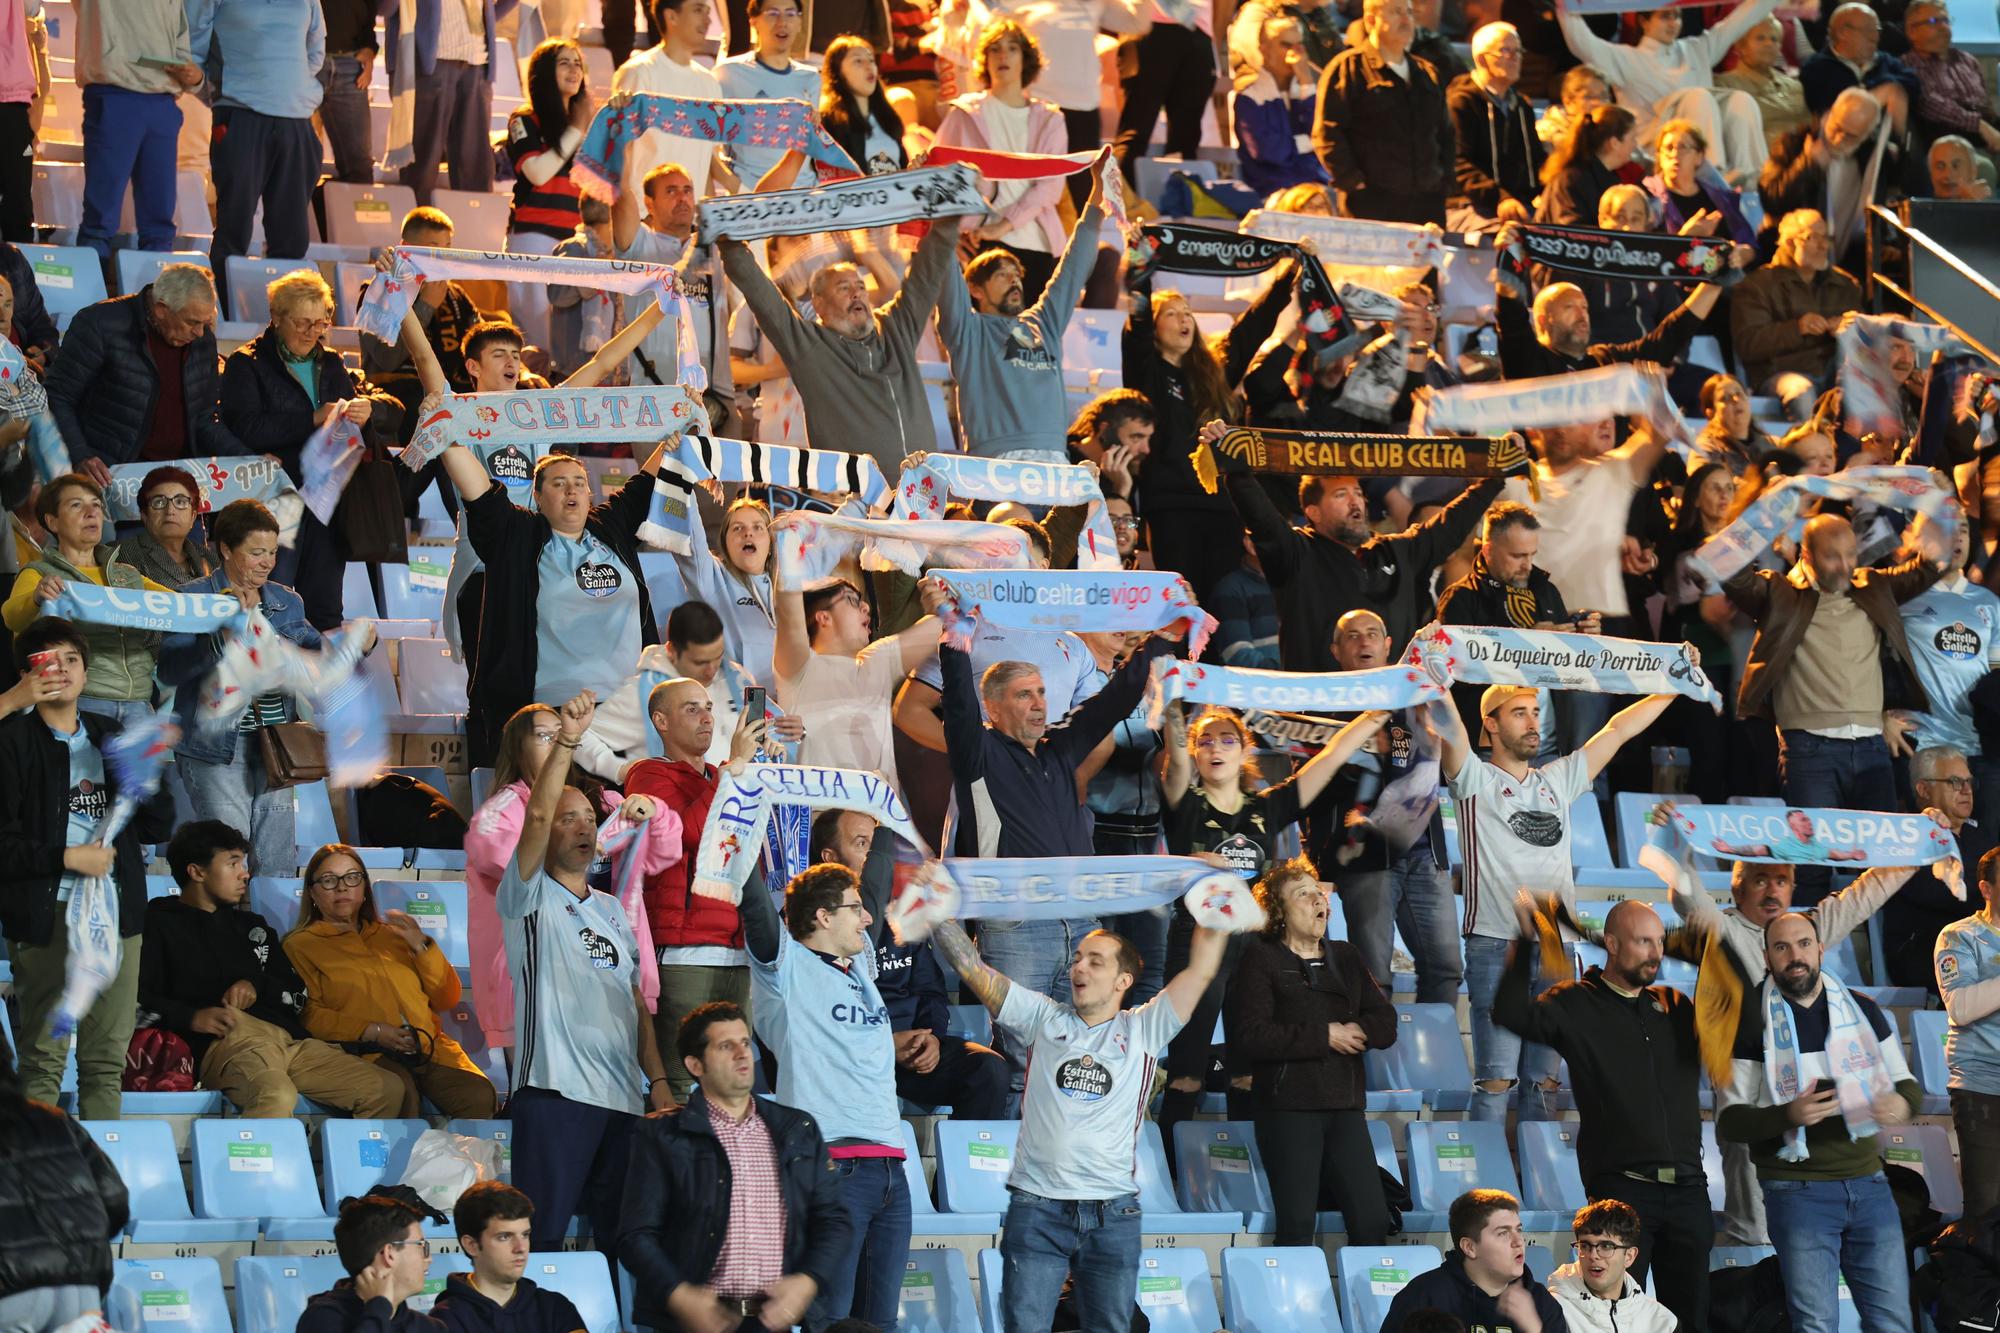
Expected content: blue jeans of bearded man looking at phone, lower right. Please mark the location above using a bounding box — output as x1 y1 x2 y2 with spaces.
1764 1171 1910 1333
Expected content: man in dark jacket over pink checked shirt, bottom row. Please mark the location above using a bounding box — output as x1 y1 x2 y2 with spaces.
618 996 848 1333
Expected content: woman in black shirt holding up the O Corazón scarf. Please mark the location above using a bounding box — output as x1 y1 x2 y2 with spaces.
1160 705 1388 1159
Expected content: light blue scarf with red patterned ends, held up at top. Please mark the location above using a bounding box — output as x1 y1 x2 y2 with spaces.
570 92 866 204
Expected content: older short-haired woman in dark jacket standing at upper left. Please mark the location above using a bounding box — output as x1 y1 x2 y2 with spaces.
220 270 402 630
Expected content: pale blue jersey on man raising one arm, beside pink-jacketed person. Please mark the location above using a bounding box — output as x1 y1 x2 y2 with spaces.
498 857 640 1115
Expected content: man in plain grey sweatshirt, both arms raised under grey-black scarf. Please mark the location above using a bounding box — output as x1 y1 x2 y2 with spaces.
718 218 960 480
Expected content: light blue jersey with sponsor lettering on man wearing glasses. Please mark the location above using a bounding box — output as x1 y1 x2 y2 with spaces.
750 929 902 1147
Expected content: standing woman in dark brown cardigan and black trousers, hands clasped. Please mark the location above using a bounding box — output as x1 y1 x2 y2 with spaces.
1226 857 1396 1245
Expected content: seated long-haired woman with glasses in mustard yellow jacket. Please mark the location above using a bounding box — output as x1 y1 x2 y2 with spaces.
284 843 496 1121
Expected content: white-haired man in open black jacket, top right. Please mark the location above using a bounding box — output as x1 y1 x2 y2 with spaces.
1444 22 1548 230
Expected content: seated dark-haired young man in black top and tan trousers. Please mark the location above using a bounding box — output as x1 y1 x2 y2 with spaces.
138 819 402 1119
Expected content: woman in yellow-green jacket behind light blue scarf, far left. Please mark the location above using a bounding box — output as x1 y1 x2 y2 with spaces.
0 472 168 723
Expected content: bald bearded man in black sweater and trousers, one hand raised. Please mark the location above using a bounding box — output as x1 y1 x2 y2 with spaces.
1492 895 1716 1329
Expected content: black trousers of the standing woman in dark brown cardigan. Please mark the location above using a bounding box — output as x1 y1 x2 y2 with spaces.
1256 1111 1388 1245
